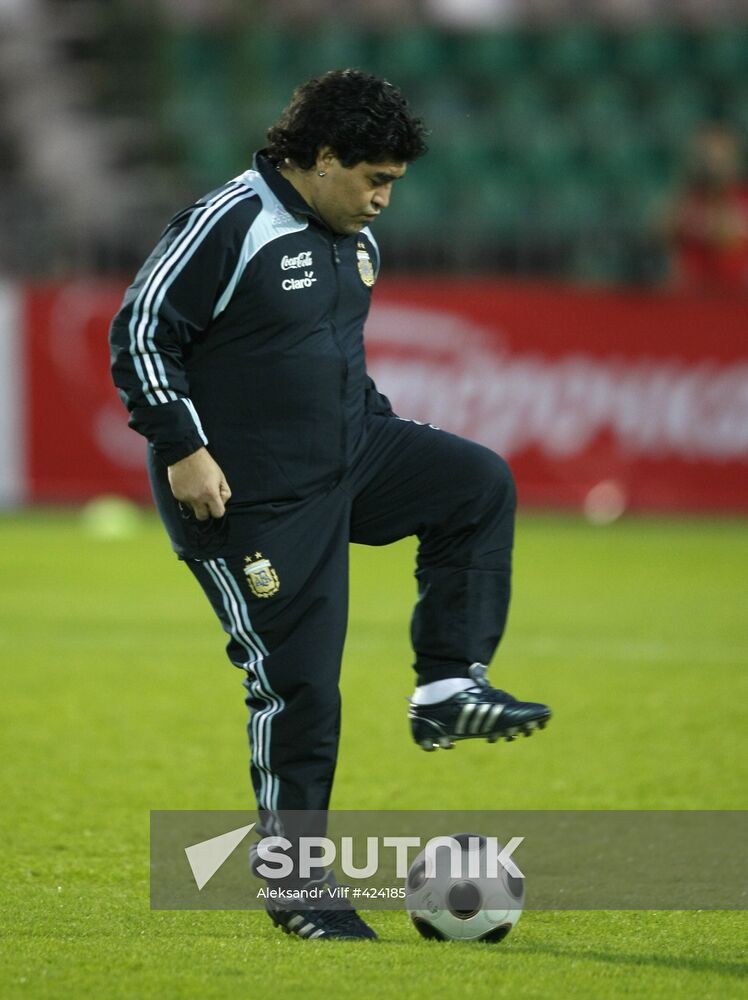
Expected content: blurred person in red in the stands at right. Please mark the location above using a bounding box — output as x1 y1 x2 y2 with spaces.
665 123 748 292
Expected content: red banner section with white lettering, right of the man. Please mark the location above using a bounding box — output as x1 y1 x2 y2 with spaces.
368 280 748 516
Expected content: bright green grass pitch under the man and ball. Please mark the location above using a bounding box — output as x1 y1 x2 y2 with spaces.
0 513 748 1000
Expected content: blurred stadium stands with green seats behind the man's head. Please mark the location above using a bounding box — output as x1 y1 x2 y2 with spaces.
0 0 748 283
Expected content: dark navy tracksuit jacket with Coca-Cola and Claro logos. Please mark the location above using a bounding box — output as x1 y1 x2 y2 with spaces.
110 153 392 504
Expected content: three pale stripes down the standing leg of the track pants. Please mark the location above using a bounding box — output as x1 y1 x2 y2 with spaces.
203 559 285 809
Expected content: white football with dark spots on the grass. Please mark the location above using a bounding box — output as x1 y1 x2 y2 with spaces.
405 833 525 941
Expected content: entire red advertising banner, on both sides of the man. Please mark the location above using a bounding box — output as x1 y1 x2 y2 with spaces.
25 278 748 512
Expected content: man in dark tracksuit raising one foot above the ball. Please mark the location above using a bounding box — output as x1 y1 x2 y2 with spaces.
111 70 550 938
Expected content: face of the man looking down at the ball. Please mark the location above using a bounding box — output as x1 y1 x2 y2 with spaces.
310 153 407 235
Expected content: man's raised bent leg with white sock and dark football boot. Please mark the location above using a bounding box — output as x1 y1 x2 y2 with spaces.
344 417 551 750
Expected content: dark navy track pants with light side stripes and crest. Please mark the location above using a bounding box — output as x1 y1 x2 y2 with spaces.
186 416 515 810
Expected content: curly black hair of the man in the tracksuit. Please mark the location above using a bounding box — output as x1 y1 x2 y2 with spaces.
266 69 427 170
